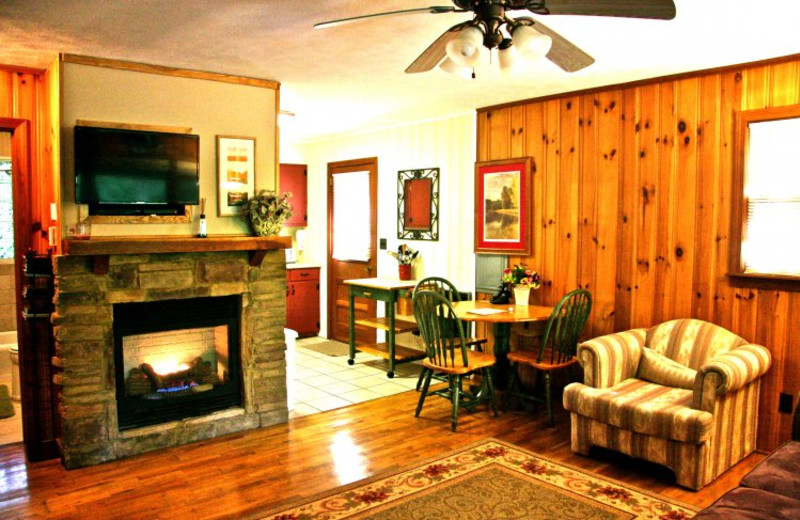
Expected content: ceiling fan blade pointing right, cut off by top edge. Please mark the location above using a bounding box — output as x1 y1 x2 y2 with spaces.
528 0 675 20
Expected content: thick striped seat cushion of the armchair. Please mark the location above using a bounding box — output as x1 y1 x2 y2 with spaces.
564 379 713 444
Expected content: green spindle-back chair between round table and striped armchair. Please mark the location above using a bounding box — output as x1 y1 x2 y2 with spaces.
503 289 592 427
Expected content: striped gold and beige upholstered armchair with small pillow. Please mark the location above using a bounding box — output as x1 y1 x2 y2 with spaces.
564 319 771 489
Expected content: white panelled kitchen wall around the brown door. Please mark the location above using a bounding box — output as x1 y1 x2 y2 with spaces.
280 113 476 336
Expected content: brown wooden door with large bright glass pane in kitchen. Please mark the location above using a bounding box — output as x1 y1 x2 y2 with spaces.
328 157 378 344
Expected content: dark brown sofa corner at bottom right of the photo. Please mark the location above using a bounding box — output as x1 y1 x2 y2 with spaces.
694 396 800 520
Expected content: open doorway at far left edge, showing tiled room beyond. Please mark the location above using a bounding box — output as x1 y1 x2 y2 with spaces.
0 130 22 445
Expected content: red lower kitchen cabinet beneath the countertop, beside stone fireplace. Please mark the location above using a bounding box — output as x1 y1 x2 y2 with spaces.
286 267 319 337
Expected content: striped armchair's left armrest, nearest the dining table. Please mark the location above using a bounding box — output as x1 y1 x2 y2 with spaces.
577 329 645 388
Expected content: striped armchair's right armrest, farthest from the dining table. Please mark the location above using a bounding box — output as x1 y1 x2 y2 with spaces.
695 344 772 409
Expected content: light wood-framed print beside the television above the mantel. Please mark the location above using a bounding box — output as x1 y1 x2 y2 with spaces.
217 135 256 217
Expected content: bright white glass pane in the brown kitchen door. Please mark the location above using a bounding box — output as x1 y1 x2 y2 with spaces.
333 172 372 262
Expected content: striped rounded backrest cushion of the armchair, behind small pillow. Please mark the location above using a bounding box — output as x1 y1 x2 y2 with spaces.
645 319 747 370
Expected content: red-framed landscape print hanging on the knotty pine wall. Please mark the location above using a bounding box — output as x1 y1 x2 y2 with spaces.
475 157 533 256
